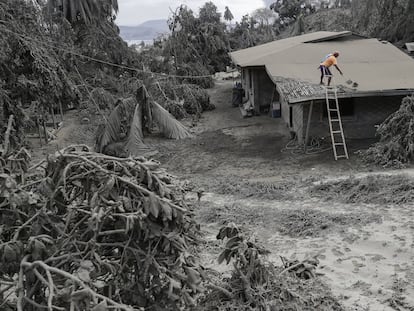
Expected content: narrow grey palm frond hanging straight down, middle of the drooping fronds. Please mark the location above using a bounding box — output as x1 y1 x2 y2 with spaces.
125 103 150 156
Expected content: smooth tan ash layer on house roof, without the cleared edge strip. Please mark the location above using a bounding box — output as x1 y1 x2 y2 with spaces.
231 32 414 101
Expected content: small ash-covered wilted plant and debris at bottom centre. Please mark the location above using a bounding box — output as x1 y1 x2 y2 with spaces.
201 223 343 311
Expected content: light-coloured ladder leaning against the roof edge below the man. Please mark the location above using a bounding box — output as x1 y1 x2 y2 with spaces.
325 76 349 160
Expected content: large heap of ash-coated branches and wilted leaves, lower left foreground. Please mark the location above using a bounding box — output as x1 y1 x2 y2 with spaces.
0 146 202 310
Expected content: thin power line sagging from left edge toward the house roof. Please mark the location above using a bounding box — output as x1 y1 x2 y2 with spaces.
0 20 211 79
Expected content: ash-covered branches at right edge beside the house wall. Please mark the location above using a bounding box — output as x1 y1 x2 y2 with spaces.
361 96 414 167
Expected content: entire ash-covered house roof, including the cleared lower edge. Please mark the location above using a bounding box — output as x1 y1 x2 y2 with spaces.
231 32 414 103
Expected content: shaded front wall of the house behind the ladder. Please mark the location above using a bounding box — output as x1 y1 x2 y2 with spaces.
293 96 404 142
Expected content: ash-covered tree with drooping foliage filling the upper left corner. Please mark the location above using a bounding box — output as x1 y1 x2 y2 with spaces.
0 0 78 149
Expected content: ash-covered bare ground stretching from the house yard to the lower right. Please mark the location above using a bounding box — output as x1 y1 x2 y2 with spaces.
160 82 414 311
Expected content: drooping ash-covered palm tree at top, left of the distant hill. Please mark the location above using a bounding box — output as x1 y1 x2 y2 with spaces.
47 0 142 95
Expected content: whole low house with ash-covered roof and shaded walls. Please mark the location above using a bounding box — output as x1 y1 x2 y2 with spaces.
230 31 414 143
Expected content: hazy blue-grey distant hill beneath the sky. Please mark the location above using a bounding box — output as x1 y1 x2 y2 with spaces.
119 19 169 41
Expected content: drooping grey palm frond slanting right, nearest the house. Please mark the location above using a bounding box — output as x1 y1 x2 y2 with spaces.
151 102 193 139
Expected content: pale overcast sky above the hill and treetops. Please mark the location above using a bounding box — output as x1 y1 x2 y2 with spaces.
116 0 265 26
